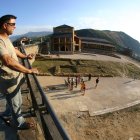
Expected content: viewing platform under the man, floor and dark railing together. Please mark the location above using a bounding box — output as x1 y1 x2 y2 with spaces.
0 47 70 140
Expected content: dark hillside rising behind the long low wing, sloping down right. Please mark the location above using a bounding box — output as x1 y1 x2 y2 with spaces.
76 29 140 57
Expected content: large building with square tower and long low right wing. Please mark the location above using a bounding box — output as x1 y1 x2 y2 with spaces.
51 25 116 54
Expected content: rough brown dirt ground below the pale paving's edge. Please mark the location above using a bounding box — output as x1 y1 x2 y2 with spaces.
60 107 140 140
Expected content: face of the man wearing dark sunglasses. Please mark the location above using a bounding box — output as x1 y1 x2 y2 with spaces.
4 19 16 35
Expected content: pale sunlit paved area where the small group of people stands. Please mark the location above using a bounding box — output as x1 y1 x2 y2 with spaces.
38 76 140 116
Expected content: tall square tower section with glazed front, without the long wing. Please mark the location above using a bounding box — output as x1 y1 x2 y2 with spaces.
51 25 81 54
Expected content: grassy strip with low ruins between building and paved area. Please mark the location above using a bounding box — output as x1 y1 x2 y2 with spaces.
33 58 140 79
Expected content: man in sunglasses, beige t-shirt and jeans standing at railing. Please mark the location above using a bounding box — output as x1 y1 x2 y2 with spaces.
0 15 38 129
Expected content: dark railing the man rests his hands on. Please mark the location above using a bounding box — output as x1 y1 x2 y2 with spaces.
20 46 70 140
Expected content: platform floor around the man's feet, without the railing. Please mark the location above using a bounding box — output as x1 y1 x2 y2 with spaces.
0 83 45 140
